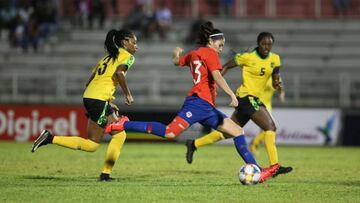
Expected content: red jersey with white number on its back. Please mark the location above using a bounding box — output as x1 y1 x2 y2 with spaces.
179 47 222 106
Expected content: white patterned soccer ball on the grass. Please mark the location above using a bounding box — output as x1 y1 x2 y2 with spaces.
239 164 261 185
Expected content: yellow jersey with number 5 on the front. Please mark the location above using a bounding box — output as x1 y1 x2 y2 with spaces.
234 50 281 98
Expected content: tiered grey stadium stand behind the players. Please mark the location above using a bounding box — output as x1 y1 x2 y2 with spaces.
0 1 360 107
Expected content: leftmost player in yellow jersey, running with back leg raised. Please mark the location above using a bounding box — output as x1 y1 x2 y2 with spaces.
31 29 137 181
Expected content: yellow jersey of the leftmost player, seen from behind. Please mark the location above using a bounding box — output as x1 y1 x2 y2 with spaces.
83 48 135 101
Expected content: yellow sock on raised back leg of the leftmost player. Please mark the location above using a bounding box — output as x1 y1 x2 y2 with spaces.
52 136 99 152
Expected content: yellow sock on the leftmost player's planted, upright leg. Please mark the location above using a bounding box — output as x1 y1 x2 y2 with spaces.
102 131 126 174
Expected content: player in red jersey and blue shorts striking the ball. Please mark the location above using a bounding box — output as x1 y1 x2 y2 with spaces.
105 22 272 182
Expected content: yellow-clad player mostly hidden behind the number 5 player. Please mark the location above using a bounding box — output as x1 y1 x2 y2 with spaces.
249 78 285 153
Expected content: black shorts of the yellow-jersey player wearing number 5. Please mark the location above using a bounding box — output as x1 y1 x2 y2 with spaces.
235 96 265 127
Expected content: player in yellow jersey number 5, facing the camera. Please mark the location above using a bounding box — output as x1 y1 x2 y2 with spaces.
186 32 292 176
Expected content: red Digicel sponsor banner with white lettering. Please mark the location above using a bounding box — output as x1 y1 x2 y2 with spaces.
0 105 87 141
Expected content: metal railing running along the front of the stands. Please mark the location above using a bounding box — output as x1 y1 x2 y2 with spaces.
0 70 360 108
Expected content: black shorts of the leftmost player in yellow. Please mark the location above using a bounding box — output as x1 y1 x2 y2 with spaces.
83 98 114 128
